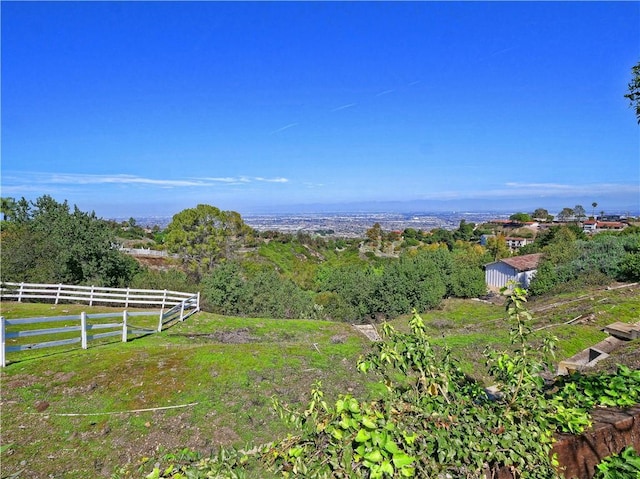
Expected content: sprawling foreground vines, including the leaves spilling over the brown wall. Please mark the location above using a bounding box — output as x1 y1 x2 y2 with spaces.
118 287 640 479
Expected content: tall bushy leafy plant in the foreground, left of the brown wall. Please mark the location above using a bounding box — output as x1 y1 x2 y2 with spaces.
263 288 574 479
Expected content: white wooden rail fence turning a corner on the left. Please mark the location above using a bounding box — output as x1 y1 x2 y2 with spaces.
0 283 200 367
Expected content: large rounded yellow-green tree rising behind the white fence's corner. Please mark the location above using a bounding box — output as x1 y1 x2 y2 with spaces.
165 204 253 279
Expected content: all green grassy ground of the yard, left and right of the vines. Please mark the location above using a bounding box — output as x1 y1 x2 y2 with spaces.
0 286 640 479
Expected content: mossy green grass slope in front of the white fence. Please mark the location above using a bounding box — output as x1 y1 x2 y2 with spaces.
1 303 376 478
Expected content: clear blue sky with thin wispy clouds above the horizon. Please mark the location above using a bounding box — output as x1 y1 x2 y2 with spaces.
1 1 640 217
